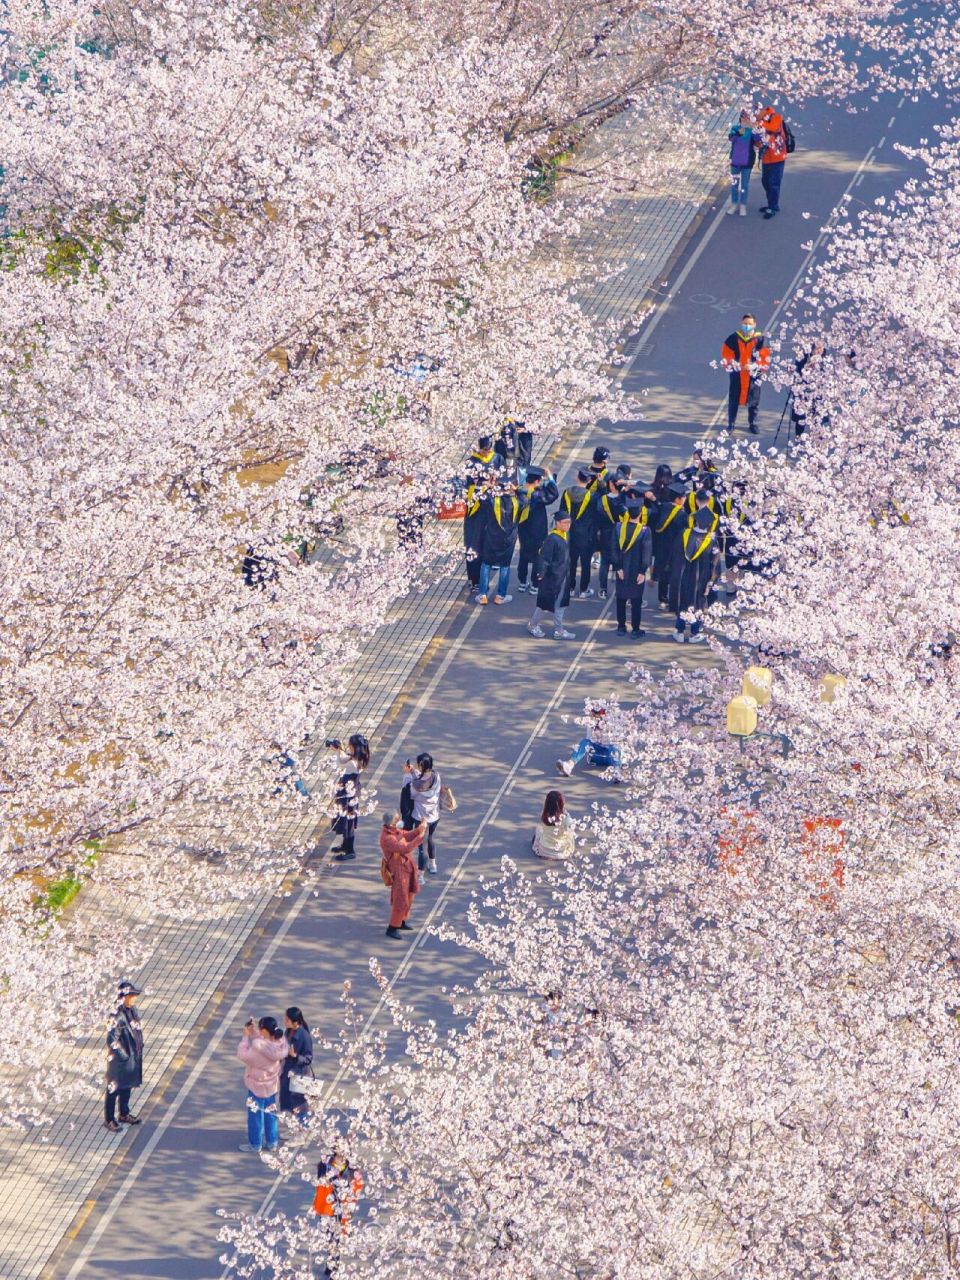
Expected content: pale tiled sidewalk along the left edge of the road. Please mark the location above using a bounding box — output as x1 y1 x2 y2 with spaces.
0 104 727 1280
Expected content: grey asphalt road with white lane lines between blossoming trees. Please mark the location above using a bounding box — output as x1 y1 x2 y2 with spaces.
55 72 946 1280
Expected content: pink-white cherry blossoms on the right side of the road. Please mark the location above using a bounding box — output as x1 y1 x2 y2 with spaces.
223 127 960 1280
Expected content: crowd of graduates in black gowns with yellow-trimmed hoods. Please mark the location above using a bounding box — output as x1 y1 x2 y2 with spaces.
462 424 745 644
